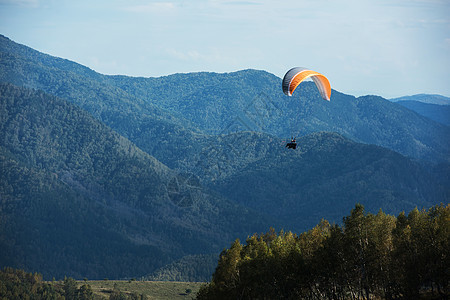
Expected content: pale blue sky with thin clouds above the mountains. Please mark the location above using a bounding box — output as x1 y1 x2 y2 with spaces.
0 0 450 98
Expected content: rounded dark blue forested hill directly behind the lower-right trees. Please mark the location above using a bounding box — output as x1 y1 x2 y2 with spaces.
185 132 450 231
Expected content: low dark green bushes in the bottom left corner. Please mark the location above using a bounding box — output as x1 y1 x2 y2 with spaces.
0 268 94 300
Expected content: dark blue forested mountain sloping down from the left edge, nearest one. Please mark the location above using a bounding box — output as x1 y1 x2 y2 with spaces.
0 84 268 279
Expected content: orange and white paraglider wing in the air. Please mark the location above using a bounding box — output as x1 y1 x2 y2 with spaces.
282 67 331 101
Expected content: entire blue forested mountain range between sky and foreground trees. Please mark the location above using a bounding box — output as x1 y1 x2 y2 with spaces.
0 36 450 280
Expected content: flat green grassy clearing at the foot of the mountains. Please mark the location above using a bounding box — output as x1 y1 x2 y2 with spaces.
79 280 205 300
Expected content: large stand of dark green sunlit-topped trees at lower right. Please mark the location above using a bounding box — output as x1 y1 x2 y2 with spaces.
197 205 450 299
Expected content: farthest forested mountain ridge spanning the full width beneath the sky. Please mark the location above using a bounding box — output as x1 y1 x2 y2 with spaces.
0 36 450 164
